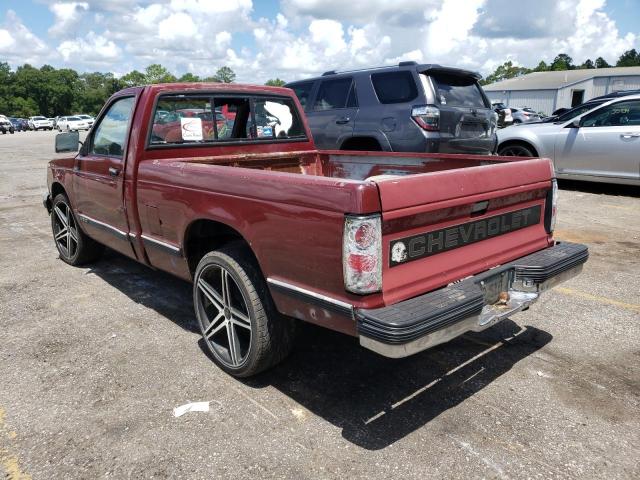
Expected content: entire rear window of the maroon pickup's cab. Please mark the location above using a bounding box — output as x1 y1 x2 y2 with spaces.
148 94 306 147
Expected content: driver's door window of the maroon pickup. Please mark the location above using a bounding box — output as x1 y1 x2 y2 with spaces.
91 97 134 158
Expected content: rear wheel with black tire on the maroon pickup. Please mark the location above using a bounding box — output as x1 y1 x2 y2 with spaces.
193 244 295 377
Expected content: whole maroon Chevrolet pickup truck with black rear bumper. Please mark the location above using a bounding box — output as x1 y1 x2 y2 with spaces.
44 84 588 376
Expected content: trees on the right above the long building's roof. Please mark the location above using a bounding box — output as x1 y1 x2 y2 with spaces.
480 48 640 85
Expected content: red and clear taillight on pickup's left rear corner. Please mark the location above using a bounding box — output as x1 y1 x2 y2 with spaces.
342 215 382 294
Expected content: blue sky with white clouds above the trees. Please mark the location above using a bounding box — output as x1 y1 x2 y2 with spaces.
0 0 640 83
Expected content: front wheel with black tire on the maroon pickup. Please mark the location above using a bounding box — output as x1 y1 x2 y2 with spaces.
51 193 104 266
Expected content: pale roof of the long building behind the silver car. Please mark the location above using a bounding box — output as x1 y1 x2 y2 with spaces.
482 67 640 92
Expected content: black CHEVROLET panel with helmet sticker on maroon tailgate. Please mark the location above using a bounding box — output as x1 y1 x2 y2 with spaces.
389 205 540 267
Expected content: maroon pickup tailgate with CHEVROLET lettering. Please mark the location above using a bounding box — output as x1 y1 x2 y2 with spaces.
371 159 553 305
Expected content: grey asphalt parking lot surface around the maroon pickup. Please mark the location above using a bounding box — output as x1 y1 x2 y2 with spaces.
0 132 640 479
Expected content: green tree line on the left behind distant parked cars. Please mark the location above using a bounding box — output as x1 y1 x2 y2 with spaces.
0 62 284 118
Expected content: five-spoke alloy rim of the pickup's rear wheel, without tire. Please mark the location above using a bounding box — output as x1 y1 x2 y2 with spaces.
196 265 252 368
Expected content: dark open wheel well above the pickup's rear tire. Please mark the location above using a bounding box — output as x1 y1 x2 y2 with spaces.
184 219 259 275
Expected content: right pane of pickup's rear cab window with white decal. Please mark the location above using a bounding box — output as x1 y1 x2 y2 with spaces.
254 98 305 139
